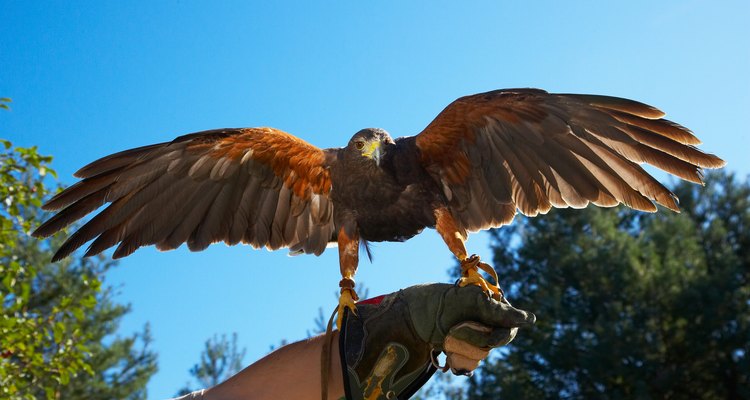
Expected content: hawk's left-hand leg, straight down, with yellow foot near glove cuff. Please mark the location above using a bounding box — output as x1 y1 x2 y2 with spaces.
336 228 359 329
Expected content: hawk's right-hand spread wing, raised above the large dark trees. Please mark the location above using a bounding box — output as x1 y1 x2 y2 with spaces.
416 89 724 231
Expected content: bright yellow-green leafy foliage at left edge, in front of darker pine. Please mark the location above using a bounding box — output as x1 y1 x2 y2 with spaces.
0 140 90 398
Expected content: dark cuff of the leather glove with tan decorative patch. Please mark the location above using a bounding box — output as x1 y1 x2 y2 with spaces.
339 293 436 400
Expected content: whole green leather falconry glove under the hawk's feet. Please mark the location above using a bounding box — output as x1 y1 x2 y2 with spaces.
339 283 536 400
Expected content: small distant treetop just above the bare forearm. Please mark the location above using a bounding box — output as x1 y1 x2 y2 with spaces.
177 333 246 396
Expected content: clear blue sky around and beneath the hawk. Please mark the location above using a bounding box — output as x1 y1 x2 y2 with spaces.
0 0 750 399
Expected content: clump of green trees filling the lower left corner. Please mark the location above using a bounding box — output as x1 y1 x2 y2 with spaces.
0 104 156 399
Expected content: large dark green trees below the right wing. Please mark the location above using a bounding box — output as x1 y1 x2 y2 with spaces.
468 173 750 399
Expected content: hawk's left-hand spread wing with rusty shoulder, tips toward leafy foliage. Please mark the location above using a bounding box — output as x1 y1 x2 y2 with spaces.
34 128 335 261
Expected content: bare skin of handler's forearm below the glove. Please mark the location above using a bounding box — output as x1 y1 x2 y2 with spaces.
203 331 344 400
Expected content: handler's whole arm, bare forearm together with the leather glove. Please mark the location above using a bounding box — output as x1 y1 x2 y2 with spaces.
176 283 535 400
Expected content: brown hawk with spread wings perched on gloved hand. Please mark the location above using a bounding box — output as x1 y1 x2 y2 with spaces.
34 89 725 322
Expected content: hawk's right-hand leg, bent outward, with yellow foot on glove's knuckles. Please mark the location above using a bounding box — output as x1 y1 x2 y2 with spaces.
435 208 504 300
